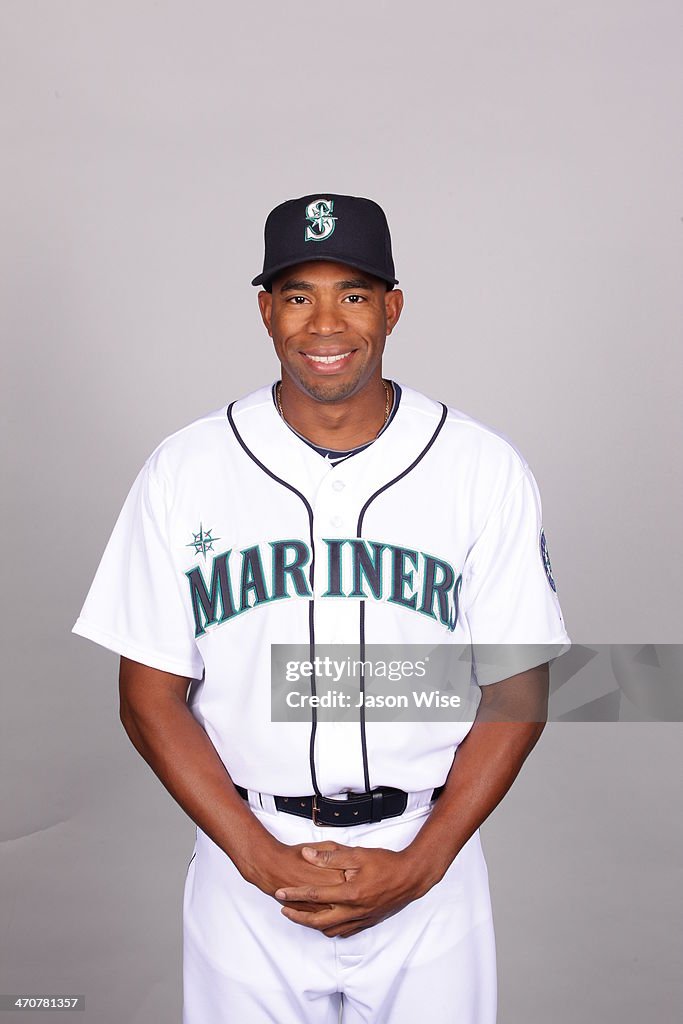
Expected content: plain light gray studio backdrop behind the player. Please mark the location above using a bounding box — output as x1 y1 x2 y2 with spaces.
0 0 683 1024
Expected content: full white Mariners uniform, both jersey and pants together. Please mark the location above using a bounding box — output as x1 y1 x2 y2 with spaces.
74 387 568 1024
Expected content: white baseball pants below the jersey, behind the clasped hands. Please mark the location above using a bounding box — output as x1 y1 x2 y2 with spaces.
183 791 497 1024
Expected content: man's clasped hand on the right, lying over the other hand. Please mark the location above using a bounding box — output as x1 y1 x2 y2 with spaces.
274 843 431 938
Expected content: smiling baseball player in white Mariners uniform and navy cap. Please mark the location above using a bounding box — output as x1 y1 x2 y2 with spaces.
74 193 569 1024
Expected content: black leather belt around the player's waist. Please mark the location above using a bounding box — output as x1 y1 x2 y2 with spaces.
234 785 444 827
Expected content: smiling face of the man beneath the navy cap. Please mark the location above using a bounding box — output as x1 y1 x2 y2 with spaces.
258 260 403 402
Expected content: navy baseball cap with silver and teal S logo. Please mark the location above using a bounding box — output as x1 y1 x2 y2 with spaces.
252 193 398 291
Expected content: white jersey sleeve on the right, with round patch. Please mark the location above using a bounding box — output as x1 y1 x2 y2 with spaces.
463 465 570 685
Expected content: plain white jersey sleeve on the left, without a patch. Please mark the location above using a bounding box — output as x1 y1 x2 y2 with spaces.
72 456 204 679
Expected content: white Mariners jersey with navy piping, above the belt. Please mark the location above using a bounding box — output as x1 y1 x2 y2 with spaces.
74 386 568 796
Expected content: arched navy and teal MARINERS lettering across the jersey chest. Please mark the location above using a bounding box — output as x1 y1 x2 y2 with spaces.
185 538 462 637
